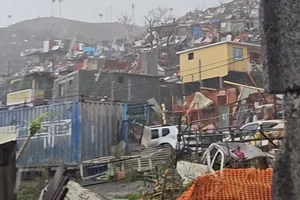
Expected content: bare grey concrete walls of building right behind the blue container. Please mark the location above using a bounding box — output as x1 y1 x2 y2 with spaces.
53 70 160 103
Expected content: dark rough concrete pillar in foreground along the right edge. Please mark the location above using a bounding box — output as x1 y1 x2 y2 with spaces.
260 0 300 200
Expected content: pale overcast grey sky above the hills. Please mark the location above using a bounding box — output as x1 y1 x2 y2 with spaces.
0 0 219 27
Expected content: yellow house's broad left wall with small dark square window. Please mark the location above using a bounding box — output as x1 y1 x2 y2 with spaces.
179 43 228 83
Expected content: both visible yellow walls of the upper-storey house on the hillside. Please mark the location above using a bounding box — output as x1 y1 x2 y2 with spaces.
179 43 260 83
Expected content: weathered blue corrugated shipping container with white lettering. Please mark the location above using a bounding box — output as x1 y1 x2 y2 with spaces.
0 102 126 167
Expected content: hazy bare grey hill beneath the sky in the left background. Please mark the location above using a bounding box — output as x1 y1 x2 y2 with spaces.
0 17 145 72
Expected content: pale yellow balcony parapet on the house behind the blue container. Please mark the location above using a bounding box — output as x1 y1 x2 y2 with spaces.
6 89 45 106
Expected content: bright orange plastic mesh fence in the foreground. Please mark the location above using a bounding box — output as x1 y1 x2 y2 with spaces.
177 169 273 200
